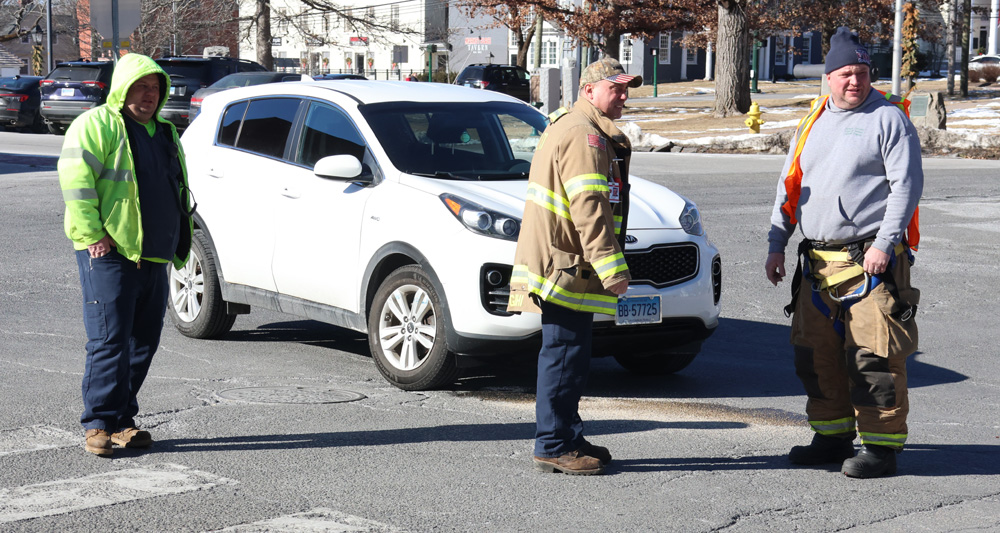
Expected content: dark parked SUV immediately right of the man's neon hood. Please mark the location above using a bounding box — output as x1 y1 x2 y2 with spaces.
155 56 267 130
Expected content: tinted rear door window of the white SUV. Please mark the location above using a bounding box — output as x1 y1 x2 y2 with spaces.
236 98 299 158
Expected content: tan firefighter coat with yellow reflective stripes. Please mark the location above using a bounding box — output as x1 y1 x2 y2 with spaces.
507 99 632 315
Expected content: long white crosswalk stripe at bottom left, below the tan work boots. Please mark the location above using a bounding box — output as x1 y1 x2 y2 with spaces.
0 463 237 524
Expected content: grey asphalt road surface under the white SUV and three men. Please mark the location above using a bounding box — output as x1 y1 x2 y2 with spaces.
0 133 1000 532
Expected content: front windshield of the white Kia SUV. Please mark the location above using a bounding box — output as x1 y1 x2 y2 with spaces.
360 102 548 180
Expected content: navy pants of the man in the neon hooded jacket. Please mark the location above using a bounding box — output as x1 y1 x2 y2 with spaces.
76 250 169 432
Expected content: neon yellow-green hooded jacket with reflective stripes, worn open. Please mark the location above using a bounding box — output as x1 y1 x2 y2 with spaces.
58 54 193 268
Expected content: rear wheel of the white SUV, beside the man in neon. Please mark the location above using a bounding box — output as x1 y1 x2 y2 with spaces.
167 230 236 339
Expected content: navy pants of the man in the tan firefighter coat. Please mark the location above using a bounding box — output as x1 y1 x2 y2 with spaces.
535 302 594 457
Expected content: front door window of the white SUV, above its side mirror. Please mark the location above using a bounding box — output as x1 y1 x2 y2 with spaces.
295 103 365 168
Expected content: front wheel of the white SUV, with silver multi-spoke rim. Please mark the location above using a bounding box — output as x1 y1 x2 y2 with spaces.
368 265 458 390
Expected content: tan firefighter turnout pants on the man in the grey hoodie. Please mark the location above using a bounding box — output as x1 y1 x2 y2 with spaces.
791 245 920 449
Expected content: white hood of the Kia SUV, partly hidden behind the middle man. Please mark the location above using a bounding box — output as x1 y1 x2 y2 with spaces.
400 174 687 230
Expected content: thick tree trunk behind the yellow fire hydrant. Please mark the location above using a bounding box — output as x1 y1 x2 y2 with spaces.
715 0 750 118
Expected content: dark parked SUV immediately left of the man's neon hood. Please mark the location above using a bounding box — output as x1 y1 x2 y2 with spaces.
39 61 114 135
